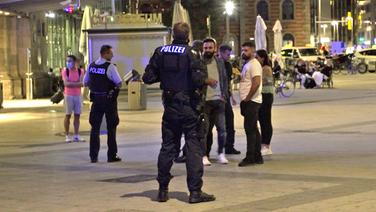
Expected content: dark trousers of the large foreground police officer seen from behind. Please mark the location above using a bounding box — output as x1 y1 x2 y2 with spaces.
157 93 204 192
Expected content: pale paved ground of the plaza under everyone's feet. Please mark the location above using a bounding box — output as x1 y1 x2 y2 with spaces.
0 74 376 212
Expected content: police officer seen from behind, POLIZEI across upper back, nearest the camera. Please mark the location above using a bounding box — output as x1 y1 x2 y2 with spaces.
143 23 215 203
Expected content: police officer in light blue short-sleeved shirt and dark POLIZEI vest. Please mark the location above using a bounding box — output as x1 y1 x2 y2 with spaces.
84 45 122 163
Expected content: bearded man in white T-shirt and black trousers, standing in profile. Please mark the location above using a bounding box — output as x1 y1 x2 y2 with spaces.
239 42 264 167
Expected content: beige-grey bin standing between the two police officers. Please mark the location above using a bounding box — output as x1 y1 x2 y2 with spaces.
128 81 146 110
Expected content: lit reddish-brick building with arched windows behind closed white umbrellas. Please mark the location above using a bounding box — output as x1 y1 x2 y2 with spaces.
212 0 313 51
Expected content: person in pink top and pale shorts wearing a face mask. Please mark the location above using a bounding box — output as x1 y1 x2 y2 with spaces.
61 55 84 142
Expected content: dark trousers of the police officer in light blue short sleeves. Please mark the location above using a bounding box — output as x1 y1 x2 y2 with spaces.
89 95 119 159
